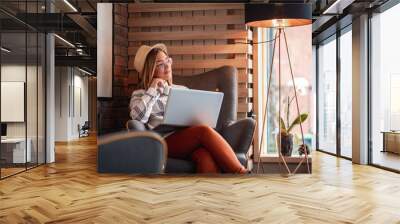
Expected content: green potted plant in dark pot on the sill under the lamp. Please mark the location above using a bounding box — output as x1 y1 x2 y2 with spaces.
277 97 308 156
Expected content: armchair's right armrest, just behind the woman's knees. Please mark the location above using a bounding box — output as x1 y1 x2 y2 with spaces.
221 118 256 154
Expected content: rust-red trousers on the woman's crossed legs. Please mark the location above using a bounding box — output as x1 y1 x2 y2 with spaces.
166 126 247 173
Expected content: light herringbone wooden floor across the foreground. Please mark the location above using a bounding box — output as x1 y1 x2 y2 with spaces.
0 134 400 224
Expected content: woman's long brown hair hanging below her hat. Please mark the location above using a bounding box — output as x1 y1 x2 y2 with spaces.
140 48 168 90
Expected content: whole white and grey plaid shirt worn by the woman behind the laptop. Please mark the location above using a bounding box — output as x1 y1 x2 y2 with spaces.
129 85 187 128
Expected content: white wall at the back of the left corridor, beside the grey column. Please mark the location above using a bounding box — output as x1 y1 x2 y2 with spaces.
55 67 89 141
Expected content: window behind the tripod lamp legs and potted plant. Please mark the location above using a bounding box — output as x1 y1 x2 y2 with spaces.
257 25 315 157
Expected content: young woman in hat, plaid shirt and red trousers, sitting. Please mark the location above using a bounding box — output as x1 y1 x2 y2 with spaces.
130 44 248 173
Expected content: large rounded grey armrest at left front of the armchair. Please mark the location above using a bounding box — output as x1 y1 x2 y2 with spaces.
97 131 167 174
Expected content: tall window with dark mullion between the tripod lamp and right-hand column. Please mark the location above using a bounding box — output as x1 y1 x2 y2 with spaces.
317 25 353 158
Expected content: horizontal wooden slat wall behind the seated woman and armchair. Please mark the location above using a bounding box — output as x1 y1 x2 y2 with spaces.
128 3 253 118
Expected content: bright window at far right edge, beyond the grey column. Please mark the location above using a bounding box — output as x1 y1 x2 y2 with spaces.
370 4 400 170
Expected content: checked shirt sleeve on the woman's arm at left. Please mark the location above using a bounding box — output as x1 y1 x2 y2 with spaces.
129 87 160 123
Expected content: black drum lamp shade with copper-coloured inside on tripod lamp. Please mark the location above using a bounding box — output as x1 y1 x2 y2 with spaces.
245 3 312 28
